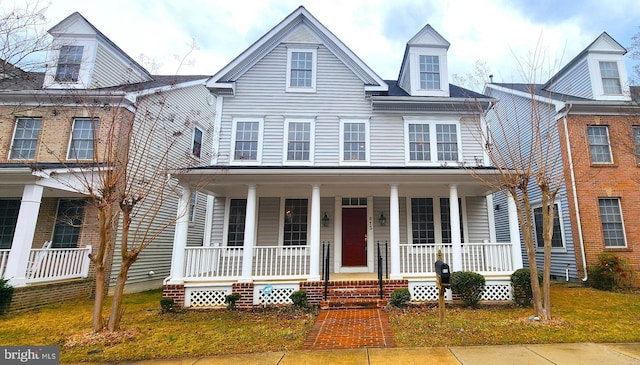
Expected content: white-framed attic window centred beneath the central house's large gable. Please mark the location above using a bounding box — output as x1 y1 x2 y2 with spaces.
286 48 317 92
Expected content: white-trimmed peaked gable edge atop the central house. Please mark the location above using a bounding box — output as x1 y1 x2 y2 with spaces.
207 6 388 92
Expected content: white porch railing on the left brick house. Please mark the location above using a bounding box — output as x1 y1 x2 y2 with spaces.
26 246 91 283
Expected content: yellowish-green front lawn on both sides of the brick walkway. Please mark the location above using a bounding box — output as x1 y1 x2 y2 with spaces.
0 284 640 362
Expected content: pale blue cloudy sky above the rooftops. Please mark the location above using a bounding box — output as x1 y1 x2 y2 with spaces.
13 0 640 82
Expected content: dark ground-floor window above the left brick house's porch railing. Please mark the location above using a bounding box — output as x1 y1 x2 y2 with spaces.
51 199 85 248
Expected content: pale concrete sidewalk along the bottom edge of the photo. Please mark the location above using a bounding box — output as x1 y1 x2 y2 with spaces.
84 343 640 365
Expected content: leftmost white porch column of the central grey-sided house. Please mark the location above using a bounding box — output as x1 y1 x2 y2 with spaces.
165 186 191 285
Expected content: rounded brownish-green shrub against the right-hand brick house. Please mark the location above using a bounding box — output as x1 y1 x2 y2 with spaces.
589 252 631 290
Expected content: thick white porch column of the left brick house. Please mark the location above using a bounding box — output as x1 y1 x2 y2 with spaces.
4 185 43 287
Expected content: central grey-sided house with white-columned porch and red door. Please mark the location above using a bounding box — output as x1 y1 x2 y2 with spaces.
164 7 522 307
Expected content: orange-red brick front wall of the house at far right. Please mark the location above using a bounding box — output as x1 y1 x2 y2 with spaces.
560 115 640 286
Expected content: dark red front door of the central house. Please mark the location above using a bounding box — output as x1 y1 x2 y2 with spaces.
342 208 367 266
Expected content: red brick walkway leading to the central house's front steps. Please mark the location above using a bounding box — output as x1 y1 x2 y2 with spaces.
302 309 395 350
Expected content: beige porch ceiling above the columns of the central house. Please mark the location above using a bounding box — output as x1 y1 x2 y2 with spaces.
174 168 499 196
